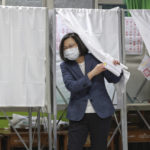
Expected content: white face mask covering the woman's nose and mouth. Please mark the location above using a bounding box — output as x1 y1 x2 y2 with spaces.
64 47 80 60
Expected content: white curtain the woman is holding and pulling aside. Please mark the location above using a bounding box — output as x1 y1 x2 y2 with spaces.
56 8 130 97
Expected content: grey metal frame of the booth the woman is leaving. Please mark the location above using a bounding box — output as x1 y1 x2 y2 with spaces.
53 9 128 150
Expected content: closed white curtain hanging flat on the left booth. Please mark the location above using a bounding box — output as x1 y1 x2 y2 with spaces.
0 6 46 107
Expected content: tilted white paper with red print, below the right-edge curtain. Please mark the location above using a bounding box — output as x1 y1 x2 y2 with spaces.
138 55 150 80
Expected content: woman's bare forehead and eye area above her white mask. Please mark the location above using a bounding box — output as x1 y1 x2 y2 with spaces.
64 37 78 50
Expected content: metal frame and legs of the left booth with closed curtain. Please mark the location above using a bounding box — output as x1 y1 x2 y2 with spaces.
0 8 52 150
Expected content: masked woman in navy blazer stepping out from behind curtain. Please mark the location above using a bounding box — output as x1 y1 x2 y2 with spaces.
60 33 122 150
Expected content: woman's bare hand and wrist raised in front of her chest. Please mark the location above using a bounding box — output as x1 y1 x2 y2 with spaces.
88 63 106 79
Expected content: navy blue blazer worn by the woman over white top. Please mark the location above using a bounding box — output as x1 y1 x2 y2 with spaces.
60 53 122 121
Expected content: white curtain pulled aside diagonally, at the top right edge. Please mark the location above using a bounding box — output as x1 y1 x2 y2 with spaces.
130 10 150 55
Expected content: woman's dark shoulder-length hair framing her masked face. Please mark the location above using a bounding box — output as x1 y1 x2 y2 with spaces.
59 33 88 61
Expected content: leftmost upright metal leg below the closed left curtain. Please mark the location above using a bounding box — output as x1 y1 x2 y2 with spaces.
28 107 32 150
